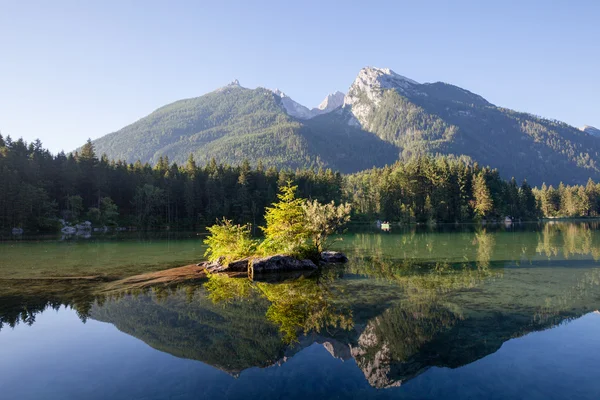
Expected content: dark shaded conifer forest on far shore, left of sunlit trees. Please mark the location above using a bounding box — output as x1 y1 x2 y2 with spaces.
0 136 342 230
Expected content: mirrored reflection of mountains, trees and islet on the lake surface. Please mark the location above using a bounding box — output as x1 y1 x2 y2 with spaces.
0 223 600 388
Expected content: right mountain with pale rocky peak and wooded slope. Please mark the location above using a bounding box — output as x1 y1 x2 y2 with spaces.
344 67 600 184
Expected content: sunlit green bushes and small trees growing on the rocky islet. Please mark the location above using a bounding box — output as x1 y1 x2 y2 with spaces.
204 181 351 265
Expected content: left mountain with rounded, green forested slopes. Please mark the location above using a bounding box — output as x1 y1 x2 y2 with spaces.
94 83 398 172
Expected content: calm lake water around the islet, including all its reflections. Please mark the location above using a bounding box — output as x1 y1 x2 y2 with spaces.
0 222 600 400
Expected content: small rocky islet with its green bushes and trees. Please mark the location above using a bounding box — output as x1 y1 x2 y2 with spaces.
198 181 351 278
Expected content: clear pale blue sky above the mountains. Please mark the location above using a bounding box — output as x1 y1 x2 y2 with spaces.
0 0 600 152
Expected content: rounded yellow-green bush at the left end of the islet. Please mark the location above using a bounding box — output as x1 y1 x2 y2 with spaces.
204 219 256 265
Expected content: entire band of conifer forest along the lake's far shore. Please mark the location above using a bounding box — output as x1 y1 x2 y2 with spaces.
0 136 600 231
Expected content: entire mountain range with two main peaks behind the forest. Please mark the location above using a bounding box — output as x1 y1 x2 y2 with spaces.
94 67 600 185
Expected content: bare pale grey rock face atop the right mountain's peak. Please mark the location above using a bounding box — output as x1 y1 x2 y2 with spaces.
344 67 419 129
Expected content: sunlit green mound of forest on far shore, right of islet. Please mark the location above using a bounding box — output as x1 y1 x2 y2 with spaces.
344 157 537 223
